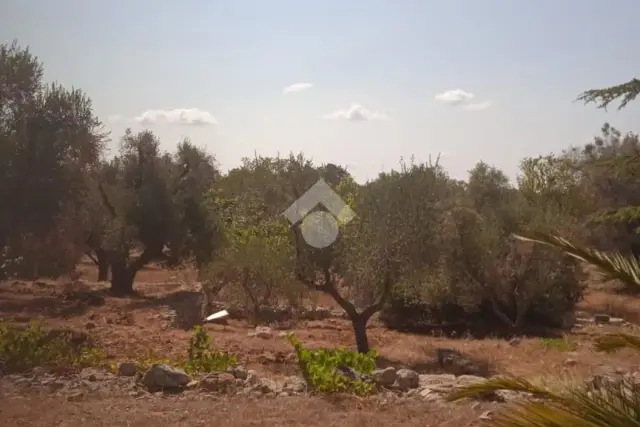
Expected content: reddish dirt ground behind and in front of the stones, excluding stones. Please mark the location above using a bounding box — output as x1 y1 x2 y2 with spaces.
0 264 640 427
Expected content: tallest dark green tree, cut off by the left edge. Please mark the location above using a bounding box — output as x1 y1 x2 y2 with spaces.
0 41 106 279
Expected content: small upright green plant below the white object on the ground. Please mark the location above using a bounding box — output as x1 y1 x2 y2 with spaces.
184 326 236 373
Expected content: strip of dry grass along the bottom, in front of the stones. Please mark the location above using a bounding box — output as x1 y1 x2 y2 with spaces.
0 397 481 427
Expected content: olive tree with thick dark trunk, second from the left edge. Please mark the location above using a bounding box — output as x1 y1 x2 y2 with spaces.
88 130 217 294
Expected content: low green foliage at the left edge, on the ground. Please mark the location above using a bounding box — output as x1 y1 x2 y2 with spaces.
0 321 104 372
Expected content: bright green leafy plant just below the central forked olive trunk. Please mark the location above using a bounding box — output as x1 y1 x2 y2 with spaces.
287 334 378 396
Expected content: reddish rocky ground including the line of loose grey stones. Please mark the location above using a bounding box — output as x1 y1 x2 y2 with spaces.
0 262 637 426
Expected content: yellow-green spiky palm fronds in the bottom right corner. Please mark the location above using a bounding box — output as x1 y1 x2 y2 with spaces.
447 377 640 427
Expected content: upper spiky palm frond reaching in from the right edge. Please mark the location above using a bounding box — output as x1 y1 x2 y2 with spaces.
514 232 640 292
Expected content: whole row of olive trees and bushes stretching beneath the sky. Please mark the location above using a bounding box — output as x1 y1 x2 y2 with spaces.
0 42 640 351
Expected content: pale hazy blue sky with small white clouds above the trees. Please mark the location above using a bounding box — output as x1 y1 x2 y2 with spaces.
0 0 640 182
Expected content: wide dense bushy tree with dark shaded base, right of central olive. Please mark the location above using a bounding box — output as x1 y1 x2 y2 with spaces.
382 164 583 334
